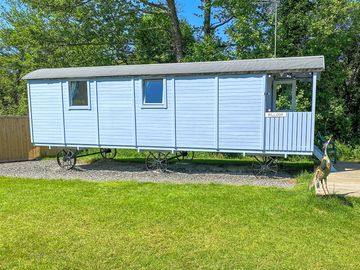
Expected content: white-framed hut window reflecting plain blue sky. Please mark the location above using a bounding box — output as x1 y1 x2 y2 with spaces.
143 79 166 108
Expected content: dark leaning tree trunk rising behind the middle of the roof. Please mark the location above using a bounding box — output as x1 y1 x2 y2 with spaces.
166 0 183 62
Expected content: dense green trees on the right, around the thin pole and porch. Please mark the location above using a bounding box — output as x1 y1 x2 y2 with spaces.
226 0 360 143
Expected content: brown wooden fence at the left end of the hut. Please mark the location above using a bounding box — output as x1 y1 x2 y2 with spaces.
0 116 55 162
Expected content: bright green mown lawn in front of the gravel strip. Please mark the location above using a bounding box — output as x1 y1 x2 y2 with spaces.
0 174 360 269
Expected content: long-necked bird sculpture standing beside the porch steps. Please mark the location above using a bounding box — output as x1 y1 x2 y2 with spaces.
309 137 331 195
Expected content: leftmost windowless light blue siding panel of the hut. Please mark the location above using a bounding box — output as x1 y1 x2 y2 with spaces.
29 81 64 144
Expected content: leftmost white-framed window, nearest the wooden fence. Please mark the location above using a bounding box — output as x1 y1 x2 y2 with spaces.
69 81 89 109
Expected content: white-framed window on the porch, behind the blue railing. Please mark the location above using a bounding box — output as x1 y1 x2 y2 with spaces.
274 81 296 111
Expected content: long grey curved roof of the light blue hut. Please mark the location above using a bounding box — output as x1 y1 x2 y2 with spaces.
22 56 325 80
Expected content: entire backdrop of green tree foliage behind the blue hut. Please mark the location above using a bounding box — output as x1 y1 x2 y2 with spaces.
0 0 360 148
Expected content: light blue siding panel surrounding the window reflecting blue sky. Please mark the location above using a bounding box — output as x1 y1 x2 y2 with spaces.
135 78 174 148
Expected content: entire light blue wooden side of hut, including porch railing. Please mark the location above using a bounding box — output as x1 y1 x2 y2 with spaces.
29 75 314 154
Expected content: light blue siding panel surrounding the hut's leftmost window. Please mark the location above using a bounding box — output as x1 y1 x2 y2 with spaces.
62 81 98 146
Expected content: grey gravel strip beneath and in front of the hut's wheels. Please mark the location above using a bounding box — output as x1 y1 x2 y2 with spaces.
0 160 294 188
